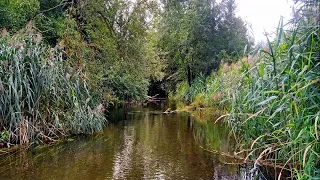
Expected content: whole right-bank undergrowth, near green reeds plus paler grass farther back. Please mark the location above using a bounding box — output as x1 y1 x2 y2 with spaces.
175 2 320 179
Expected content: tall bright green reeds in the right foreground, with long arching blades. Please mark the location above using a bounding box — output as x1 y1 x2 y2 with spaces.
228 1 320 179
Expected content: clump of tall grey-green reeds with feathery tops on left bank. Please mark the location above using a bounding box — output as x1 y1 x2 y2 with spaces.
0 27 106 144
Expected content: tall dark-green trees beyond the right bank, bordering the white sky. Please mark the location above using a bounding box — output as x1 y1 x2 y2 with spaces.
159 0 252 90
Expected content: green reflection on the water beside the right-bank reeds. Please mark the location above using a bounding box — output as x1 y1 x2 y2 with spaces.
191 110 238 176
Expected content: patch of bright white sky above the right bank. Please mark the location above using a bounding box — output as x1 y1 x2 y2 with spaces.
236 0 293 42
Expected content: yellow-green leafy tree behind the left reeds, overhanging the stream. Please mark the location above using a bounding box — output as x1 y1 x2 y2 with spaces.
69 0 162 100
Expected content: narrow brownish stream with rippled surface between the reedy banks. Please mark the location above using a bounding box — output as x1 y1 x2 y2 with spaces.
0 100 248 180
